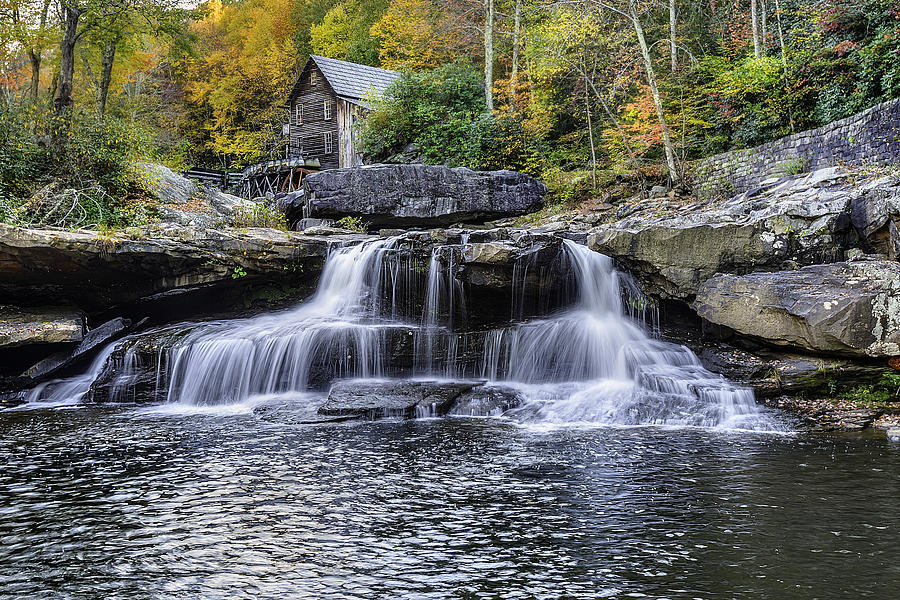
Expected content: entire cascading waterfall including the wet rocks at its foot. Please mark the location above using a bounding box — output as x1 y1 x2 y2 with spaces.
24 236 780 429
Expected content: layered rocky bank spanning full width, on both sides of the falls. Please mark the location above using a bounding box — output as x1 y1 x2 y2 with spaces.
0 162 900 428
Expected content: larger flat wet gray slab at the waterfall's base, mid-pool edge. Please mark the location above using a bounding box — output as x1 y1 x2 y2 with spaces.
318 380 475 419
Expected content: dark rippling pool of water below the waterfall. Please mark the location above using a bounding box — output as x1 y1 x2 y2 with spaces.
0 401 900 600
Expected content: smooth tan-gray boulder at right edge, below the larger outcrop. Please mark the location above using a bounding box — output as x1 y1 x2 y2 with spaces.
693 261 900 357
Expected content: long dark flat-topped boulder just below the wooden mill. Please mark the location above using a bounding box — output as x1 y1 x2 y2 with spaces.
282 165 546 227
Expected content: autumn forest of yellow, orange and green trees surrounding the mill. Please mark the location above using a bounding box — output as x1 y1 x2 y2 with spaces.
0 0 900 225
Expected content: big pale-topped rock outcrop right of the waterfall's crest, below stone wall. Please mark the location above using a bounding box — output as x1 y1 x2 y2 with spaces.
588 168 856 300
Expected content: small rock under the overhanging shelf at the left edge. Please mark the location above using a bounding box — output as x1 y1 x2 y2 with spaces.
0 305 85 348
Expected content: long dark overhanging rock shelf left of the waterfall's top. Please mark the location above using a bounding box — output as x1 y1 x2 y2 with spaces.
0 224 363 311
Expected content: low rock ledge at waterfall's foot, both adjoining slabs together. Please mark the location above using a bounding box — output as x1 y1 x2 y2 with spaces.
318 380 522 419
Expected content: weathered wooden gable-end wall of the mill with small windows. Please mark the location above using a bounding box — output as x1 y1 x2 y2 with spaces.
290 62 343 169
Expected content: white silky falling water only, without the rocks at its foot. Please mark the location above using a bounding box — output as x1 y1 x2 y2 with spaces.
17 238 779 430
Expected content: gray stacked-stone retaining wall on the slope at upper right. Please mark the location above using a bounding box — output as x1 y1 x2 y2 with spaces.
696 100 900 196
